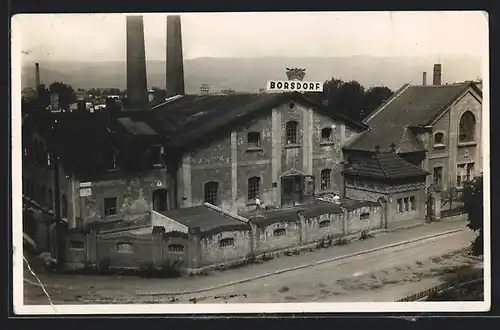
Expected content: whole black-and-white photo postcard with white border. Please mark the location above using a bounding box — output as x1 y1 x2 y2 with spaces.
12 11 491 314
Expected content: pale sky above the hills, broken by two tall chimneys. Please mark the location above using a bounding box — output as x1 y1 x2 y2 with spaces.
12 11 488 62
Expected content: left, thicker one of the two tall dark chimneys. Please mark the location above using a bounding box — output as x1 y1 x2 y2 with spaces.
127 16 149 110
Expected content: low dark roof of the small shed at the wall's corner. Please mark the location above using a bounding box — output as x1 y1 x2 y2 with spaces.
160 205 250 233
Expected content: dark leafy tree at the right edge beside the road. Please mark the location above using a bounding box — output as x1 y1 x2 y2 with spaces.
463 175 484 256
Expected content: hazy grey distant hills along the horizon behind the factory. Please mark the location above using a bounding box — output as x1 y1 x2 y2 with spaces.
22 56 481 93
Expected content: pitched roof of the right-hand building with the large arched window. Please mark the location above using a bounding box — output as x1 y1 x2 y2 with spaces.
346 82 480 153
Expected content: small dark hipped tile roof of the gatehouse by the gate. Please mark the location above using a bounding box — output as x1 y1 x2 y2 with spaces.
343 152 429 180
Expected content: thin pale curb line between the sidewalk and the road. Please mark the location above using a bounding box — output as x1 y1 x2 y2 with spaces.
136 228 465 296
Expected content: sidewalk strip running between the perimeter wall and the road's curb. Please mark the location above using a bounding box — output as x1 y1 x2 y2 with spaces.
30 220 466 295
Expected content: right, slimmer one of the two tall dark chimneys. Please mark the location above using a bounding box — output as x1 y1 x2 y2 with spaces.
167 15 184 97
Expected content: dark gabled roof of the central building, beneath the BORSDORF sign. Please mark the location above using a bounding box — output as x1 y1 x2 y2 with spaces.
153 93 367 148
